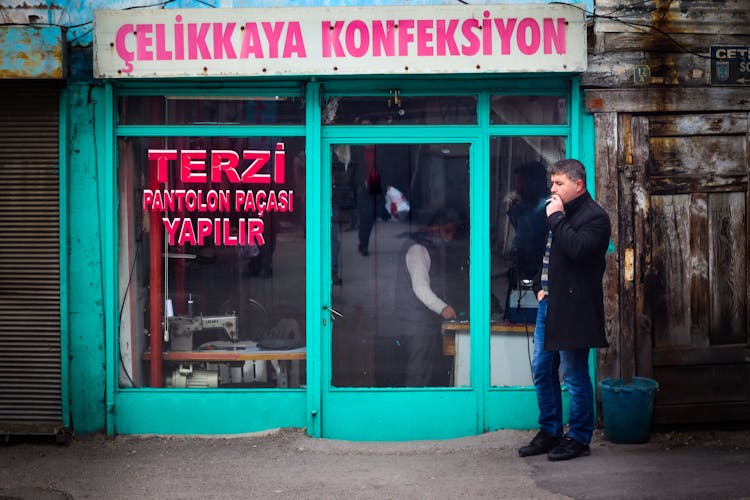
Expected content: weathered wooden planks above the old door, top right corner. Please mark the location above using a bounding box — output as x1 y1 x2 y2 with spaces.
582 0 750 88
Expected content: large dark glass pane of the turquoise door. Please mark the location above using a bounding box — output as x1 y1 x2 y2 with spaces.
331 144 469 387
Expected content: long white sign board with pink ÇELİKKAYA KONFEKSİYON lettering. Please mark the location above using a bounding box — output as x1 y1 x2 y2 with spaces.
94 4 586 78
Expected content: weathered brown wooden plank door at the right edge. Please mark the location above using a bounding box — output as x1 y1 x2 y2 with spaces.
643 112 750 423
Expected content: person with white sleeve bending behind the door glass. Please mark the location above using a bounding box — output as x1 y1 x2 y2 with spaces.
393 210 458 387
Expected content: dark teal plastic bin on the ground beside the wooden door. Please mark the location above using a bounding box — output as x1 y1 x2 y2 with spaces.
599 377 659 443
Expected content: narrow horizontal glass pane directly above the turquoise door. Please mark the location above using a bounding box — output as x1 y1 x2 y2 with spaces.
322 96 477 125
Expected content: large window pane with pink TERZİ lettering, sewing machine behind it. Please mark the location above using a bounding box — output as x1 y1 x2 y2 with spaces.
118 137 306 388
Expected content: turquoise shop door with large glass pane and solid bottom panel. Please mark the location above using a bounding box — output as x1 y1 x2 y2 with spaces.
322 141 476 439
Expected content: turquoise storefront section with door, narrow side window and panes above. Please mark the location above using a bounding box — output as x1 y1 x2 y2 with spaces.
316 88 570 440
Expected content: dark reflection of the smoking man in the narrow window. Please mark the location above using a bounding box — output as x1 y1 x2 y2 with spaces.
508 161 549 287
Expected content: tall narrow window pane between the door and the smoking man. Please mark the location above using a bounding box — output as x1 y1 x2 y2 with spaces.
490 137 565 386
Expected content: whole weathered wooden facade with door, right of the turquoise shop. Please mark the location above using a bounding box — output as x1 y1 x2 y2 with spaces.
581 0 750 424
